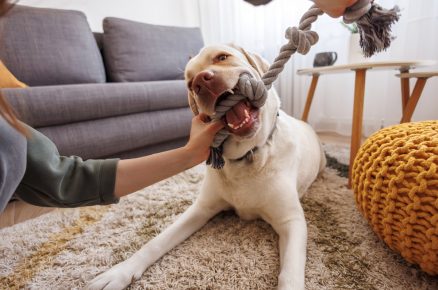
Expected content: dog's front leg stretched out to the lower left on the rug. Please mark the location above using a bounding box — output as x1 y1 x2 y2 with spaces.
86 200 227 290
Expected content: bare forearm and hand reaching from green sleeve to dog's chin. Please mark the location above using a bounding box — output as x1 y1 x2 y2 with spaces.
115 115 223 197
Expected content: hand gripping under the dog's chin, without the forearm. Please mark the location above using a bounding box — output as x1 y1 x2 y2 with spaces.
185 113 224 164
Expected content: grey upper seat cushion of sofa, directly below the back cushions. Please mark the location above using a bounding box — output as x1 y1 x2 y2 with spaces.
3 80 188 127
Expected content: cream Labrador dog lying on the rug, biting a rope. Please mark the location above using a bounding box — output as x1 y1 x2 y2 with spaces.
87 45 325 290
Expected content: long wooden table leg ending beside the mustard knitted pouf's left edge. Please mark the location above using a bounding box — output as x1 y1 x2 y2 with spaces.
348 69 366 188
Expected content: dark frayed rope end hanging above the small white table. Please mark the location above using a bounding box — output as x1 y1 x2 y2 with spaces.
356 3 400 57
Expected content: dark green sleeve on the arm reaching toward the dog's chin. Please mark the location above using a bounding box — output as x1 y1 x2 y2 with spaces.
16 127 119 207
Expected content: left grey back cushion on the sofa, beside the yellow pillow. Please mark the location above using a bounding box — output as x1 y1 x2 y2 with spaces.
0 5 106 86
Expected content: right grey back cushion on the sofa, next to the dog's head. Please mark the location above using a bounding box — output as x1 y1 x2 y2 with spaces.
103 17 203 82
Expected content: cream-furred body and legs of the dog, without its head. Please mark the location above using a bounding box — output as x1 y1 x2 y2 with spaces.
87 45 325 289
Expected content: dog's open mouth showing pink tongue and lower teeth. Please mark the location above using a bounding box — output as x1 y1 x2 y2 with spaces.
215 90 259 136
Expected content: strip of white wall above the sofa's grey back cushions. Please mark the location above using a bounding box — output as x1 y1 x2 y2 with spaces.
19 0 199 31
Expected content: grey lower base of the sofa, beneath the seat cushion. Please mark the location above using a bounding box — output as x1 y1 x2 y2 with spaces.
37 107 193 159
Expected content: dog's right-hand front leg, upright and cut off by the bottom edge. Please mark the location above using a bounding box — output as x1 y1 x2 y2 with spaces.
273 201 307 290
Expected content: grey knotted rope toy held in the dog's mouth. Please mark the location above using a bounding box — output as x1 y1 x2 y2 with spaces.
207 0 400 169
